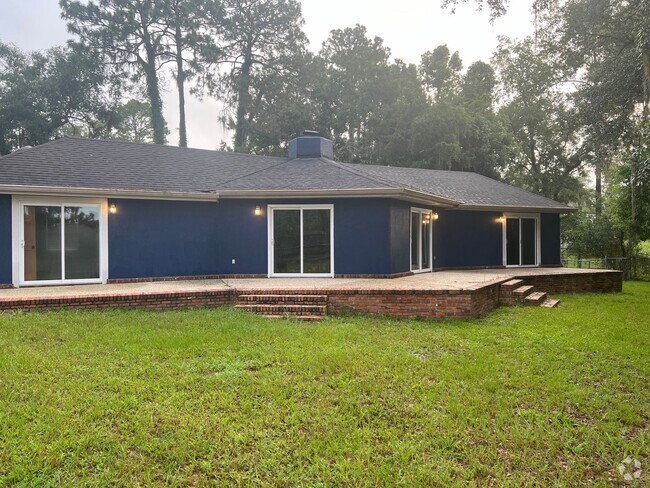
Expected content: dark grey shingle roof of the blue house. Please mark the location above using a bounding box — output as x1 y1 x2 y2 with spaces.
0 138 571 211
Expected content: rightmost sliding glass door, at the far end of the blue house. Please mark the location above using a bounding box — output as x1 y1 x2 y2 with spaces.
504 216 539 266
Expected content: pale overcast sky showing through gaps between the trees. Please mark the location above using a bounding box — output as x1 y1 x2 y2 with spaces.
0 0 533 149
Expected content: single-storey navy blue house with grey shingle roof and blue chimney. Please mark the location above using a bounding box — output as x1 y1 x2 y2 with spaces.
0 133 573 287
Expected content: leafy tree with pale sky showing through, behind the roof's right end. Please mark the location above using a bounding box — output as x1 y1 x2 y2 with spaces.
493 38 584 202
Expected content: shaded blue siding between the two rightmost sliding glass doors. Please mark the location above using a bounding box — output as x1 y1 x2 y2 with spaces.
433 210 503 268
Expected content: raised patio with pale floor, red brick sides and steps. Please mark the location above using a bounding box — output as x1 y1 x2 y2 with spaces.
0 268 622 319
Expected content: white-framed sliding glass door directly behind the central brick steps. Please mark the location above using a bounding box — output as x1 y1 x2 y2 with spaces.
269 206 334 276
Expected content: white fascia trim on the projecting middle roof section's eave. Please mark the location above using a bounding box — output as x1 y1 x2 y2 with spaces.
219 188 460 207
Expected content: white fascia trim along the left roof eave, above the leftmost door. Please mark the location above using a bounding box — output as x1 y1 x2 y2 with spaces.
0 185 219 202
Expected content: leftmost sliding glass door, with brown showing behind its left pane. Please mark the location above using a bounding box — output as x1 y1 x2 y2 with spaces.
19 199 102 285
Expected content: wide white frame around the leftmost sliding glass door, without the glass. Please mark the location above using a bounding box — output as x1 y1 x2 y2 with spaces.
11 195 108 287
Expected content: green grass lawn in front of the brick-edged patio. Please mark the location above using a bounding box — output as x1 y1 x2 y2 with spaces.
0 283 650 486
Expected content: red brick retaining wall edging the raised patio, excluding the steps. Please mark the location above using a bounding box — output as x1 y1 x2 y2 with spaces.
0 271 623 319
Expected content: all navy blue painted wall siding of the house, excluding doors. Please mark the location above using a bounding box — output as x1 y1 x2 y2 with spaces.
0 195 560 284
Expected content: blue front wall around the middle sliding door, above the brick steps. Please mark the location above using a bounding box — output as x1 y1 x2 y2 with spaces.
108 198 390 279
